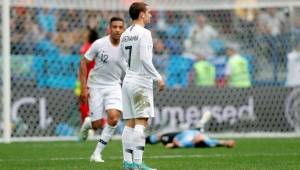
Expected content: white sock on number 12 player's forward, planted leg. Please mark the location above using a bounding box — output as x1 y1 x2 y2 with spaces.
94 124 116 155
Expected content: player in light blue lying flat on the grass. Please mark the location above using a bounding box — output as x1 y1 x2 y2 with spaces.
146 130 235 148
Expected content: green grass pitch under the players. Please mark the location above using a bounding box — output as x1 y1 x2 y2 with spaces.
0 138 300 170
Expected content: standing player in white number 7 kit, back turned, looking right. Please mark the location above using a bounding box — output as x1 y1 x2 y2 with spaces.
120 2 165 170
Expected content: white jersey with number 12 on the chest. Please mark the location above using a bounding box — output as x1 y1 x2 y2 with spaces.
84 36 125 88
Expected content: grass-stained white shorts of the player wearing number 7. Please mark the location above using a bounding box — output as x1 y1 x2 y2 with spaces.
122 82 154 119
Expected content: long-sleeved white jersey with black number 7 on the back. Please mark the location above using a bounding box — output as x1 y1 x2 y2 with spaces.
120 25 161 87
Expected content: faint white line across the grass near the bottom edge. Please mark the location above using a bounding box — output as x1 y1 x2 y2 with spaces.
0 153 300 162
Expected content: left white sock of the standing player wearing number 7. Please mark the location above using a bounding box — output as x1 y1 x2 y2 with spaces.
122 126 134 163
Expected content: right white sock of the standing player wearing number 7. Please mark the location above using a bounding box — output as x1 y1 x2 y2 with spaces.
133 125 146 164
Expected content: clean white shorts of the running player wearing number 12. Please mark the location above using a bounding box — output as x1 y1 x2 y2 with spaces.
89 86 123 121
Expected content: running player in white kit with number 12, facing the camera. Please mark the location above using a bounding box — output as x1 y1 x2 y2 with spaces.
79 17 126 162
